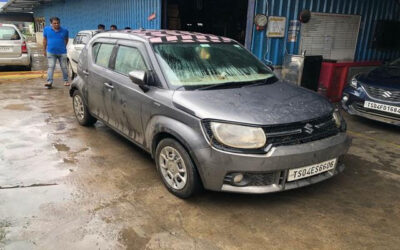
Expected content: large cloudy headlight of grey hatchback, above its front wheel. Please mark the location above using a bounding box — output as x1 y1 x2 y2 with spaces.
210 122 267 149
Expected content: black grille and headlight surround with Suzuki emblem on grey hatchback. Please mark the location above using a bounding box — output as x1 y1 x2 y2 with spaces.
204 114 339 154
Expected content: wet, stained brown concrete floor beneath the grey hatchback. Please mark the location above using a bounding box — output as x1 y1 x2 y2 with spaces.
0 79 400 249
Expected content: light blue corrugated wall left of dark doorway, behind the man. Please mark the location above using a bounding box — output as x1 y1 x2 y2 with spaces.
34 0 161 37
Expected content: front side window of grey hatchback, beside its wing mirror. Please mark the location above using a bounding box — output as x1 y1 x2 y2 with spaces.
115 46 146 75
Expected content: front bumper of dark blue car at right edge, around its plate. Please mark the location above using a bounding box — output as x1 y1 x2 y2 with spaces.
342 88 400 126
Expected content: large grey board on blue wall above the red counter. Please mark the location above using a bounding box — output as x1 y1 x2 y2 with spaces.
300 12 361 61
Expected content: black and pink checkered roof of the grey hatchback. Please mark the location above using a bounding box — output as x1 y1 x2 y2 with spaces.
102 29 234 43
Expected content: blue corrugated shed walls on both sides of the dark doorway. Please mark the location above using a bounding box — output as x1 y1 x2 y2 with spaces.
34 0 400 65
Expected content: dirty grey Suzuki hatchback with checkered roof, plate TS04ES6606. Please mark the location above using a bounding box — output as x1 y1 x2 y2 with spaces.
70 30 351 198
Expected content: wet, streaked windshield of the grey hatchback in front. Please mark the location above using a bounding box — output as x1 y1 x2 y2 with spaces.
154 43 276 90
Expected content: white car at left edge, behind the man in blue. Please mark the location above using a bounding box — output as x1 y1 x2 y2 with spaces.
0 23 31 70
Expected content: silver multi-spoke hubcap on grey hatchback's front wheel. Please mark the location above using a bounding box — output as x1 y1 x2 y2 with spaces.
159 146 187 190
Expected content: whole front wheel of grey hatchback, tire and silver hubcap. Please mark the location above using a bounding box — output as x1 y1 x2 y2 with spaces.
155 138 202 199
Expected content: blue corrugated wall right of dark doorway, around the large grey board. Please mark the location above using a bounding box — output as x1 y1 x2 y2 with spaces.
252 0 400 65
